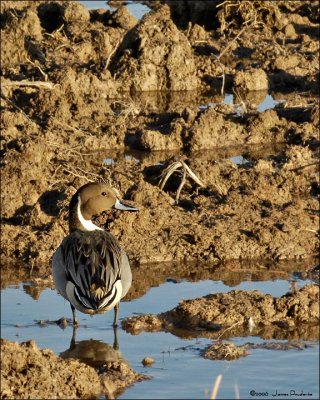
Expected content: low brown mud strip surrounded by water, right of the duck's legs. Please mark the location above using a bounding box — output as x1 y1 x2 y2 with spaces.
123 285 319 340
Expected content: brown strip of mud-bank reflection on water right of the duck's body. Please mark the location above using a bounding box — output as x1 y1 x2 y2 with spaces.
126 258 316 299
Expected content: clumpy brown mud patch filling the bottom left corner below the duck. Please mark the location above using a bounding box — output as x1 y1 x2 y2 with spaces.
1 339 143 399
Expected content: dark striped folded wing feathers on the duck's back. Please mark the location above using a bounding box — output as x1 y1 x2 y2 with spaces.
61 231 122 310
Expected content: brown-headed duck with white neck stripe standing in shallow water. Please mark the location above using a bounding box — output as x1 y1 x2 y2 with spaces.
52 182 139 327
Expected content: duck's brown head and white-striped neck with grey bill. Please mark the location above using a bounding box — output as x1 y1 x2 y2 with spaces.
69 182 138 231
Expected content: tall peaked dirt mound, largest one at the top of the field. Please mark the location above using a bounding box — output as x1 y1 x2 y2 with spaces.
111 6 198 91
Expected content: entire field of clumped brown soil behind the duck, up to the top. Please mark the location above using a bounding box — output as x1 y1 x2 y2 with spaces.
1 0 319 396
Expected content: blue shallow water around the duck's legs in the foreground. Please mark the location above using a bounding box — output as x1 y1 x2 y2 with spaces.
1 276 319 399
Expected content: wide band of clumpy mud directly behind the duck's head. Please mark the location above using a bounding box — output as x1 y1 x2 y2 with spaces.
2 139 319 274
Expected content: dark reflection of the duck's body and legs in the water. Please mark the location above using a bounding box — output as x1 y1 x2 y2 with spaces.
60 327 126 369
